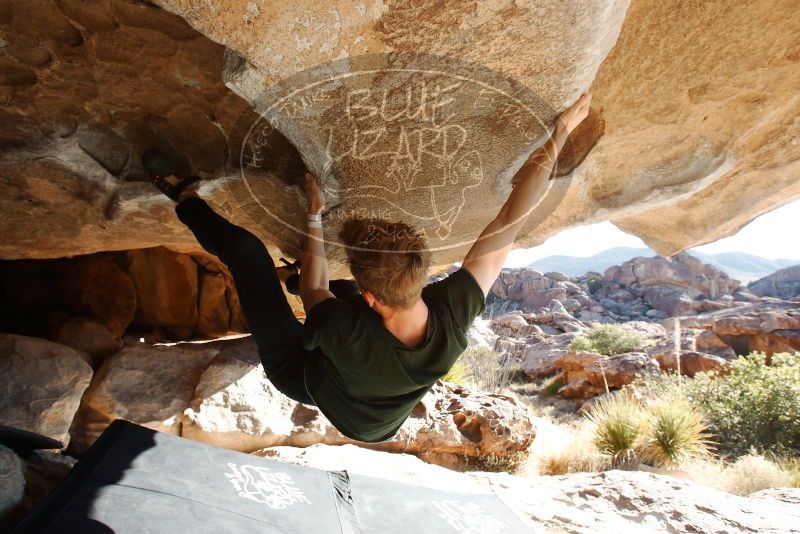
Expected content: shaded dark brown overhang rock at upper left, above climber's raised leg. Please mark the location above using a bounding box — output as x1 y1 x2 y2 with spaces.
0 0 255 258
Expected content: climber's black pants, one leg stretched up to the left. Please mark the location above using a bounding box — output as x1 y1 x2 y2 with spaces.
175 197 358 404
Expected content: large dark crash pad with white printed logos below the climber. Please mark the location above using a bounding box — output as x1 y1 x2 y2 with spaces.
14 420 528 534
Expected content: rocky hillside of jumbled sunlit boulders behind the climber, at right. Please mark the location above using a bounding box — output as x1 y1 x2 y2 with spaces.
472 254 800 407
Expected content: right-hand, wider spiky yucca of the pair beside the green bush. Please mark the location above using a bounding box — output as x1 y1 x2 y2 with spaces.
636 398 713 467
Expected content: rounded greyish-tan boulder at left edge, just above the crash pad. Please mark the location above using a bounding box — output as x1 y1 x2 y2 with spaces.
0 334 92 446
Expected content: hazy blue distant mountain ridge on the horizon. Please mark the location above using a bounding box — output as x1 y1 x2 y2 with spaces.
528 247 800 284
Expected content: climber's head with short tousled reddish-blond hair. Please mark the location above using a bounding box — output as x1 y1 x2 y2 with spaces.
339 219 431 309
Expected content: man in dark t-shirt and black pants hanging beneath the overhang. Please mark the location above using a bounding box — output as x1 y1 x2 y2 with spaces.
147 94 591 442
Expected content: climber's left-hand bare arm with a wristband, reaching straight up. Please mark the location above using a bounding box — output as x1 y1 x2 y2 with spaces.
300 172 334 313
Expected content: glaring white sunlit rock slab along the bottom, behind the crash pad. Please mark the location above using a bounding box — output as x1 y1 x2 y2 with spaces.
256 445 800 534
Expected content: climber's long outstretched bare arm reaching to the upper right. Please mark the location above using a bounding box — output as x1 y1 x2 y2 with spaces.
464 94 591 295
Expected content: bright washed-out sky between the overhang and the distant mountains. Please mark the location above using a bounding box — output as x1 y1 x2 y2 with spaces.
506 200 800 267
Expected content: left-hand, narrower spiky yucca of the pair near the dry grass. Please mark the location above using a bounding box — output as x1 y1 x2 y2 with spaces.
586 393 643 467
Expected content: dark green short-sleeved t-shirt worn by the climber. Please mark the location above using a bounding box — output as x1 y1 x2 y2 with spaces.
303 268 486 442
